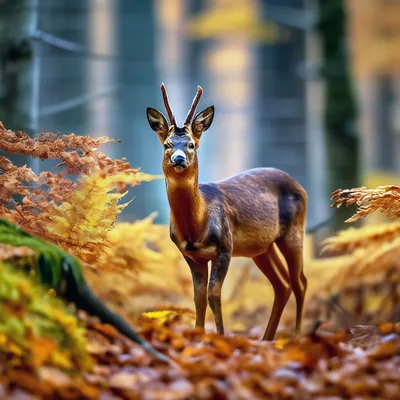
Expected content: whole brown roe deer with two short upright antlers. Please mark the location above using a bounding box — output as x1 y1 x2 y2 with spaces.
147 84 307 340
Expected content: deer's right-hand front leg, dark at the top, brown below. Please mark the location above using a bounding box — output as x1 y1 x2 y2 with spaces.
208 250 231 335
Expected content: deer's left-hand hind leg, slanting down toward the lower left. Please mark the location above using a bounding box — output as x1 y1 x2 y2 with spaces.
253 244 292 340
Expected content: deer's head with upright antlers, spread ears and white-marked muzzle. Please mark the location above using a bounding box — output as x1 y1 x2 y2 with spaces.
147 84 214 175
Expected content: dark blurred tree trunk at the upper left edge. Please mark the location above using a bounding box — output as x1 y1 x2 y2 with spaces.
0 0 35 164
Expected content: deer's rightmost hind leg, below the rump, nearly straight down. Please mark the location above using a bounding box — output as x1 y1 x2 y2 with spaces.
276 224 307 332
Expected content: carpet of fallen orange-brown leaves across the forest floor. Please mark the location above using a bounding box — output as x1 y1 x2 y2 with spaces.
0 310 400 400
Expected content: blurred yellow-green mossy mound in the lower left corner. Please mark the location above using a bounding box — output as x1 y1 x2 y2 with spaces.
0 260 92 371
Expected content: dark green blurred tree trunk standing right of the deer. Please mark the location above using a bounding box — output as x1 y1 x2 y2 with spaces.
317 0 360 230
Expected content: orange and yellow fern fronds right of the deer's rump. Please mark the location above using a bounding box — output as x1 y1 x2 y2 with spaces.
294 186 400 327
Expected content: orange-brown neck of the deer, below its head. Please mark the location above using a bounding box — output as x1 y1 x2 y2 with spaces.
166 176 206 241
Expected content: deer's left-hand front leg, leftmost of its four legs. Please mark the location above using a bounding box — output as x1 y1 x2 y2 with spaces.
185 257 208 329
